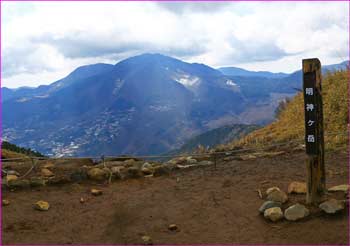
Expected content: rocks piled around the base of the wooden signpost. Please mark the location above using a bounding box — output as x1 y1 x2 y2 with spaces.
259 182 349 222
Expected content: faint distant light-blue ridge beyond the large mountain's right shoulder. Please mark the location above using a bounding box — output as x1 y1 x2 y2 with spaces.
218 67 288 78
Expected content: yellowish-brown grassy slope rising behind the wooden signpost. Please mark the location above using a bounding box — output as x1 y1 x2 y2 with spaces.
221 70 349 149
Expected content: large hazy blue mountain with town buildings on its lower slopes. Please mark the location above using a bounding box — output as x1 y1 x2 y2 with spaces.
2 54 348 156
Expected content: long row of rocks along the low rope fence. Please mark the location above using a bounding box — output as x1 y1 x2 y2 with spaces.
2 155 213 189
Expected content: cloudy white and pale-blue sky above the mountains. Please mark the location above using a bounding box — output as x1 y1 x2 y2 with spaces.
1 1 349 88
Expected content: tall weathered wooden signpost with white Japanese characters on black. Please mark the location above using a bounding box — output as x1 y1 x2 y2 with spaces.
303 58 326 204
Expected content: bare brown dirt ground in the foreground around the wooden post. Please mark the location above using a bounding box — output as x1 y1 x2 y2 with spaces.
2 152 349 244
